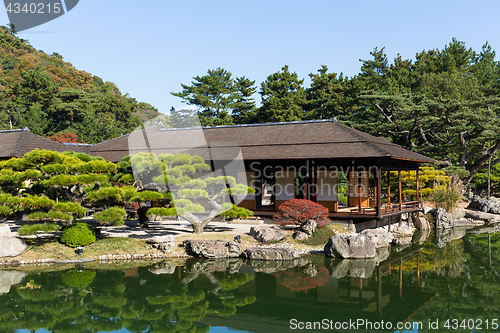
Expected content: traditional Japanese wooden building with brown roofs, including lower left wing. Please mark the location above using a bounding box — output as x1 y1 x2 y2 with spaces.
0 120 435 222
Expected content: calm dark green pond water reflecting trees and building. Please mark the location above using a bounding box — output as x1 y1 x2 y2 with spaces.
0 231 500 333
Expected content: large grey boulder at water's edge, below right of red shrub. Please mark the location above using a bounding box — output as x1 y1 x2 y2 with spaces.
324 234 376 259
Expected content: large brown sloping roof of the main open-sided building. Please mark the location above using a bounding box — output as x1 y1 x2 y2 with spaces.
90 120 434 162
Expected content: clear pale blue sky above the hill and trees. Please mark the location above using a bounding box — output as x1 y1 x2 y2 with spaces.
2 0 500 112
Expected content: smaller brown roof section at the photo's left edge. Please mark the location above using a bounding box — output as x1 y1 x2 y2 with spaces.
0 130 90 158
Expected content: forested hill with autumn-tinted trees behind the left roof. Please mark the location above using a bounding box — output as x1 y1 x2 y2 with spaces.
0 26 158 143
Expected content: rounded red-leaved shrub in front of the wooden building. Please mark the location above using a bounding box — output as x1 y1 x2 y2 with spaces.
274 199 330 226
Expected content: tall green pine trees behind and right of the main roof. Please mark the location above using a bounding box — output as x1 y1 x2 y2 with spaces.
171 39 500 188
